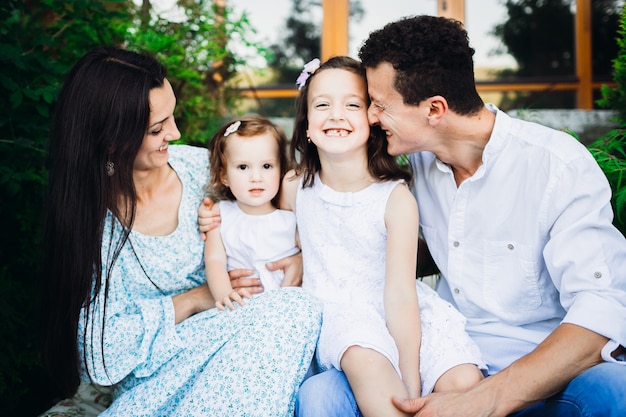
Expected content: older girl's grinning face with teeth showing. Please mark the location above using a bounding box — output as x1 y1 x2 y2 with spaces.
307 69 370 154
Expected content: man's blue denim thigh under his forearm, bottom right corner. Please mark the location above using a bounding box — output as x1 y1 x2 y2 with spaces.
510 362 626 417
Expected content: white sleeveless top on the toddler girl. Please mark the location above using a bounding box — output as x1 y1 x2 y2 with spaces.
219 201 300 294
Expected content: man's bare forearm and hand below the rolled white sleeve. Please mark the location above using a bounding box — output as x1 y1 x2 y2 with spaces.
393 323 608 417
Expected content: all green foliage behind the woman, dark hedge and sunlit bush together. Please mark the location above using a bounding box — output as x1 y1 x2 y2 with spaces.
0 0 264 415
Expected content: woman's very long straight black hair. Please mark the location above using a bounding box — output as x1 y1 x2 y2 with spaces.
41 47 166 396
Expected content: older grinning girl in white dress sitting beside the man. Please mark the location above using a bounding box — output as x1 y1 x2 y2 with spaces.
281 57 483 417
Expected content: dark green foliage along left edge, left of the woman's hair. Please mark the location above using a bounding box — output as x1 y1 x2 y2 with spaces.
0 0 124 415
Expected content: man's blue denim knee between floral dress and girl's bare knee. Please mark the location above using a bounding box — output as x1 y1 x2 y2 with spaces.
296 368 362 417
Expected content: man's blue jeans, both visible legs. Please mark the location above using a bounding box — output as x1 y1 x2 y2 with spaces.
296 363 626 417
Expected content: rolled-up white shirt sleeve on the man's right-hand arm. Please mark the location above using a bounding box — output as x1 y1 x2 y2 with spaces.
544 151 626 345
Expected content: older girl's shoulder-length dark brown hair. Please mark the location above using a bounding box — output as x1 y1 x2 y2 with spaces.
290 56 411 187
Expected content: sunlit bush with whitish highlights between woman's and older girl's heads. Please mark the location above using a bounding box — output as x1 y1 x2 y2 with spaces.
126 0 265 143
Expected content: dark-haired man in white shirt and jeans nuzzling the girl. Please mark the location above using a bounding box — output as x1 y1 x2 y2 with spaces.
298 16 626 417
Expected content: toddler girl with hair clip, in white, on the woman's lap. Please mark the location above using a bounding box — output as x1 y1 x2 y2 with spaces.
205 117 299 310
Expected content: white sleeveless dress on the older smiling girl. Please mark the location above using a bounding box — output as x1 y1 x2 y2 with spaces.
296 176 485 395
